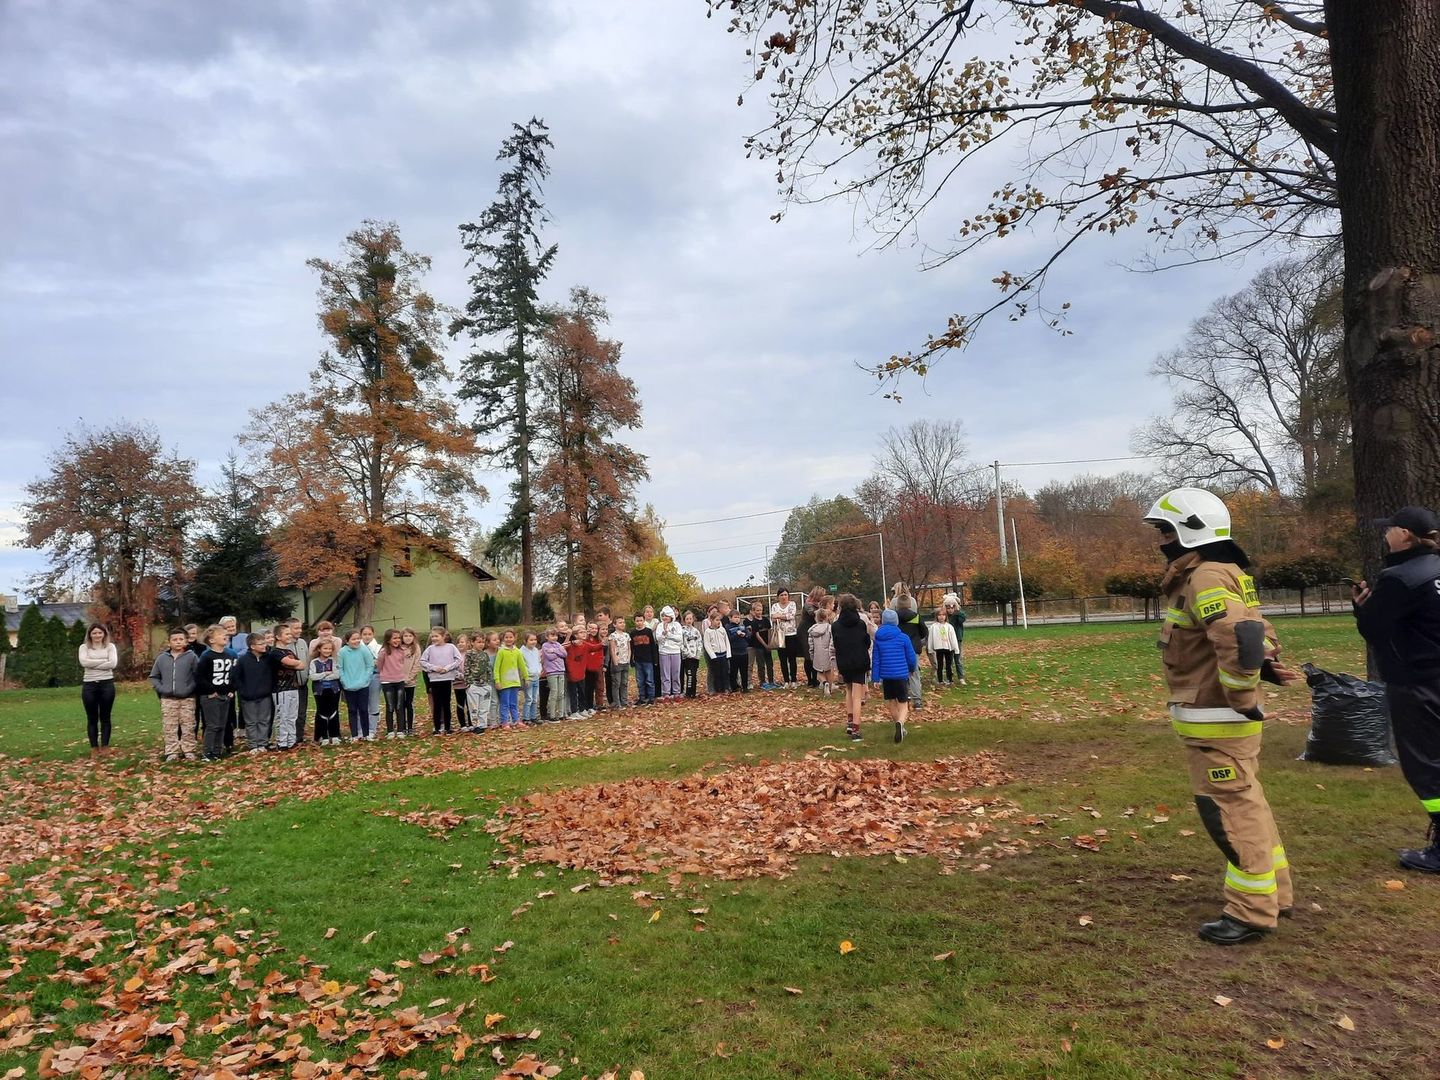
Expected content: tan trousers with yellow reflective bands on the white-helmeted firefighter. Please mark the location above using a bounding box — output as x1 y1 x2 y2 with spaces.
1181 734 1295 929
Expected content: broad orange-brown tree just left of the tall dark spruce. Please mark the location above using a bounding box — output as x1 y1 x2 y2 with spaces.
243 220 485 622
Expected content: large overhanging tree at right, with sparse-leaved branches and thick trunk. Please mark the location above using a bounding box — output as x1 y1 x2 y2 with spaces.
708 0 1440 570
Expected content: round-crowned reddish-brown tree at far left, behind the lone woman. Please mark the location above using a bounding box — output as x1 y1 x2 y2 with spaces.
23 422 204 664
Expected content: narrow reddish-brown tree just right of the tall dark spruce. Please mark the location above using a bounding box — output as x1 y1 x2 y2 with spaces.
534 288 649 612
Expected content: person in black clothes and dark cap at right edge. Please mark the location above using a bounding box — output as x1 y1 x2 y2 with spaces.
1354 507 1440 874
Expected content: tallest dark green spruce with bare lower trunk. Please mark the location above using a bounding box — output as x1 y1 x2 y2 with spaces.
449 117 556 622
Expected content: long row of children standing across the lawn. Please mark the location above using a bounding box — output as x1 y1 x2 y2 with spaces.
150 590 965 762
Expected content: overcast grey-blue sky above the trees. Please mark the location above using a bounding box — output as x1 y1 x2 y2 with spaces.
0 0 1259 592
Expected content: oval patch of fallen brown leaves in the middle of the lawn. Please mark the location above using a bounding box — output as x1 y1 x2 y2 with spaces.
490 753 1025 878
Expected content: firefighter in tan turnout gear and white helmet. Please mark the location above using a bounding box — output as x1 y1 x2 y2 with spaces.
1145 488 1299 945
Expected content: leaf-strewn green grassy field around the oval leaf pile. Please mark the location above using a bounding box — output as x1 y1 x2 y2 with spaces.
0 618 1440 1080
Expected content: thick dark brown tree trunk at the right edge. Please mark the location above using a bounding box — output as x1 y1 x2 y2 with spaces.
1325 0 1440 572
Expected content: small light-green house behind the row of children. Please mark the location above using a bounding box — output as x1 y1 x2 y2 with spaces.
291 534 495 638
